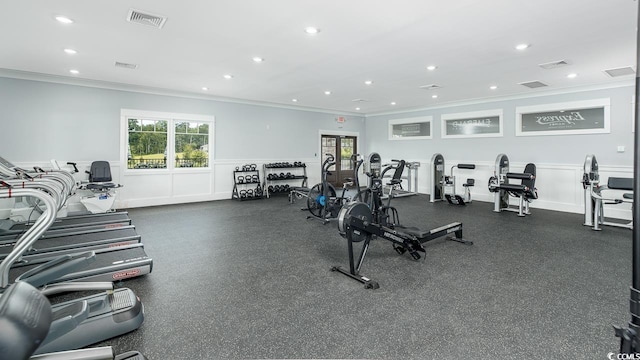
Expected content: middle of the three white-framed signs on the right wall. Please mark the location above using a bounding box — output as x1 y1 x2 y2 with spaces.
441 109 502 139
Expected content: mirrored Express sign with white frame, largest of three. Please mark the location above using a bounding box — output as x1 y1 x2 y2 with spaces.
516 99 610 136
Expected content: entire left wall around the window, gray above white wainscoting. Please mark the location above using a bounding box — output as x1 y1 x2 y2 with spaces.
0 77 365 207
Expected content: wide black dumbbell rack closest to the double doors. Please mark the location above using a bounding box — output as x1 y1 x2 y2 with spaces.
262 161 307 198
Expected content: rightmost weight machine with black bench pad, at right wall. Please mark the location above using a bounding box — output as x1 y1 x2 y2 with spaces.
582 155 633 231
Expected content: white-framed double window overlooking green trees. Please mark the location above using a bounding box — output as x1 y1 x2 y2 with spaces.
121 109 213 169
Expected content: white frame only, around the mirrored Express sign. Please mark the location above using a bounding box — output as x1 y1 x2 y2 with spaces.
516 98 611 136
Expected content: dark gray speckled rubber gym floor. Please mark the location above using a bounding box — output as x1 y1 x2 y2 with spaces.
90 195 631 360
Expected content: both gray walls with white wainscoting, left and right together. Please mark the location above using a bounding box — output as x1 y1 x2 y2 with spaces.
0 78 633 217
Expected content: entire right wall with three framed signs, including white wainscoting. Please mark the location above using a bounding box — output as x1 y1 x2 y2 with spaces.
366 86 634 218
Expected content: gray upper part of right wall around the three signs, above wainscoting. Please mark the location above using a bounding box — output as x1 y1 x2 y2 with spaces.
366 86 634 166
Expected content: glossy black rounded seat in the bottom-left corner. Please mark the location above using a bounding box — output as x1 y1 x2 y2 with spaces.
0 281 52 360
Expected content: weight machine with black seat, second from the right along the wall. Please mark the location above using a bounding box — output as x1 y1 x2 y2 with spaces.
489 154 538 217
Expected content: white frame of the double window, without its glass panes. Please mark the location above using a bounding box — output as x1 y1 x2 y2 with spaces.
120 109 215 175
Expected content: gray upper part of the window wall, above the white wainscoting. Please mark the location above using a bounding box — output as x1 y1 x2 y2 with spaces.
0 78 365 162
